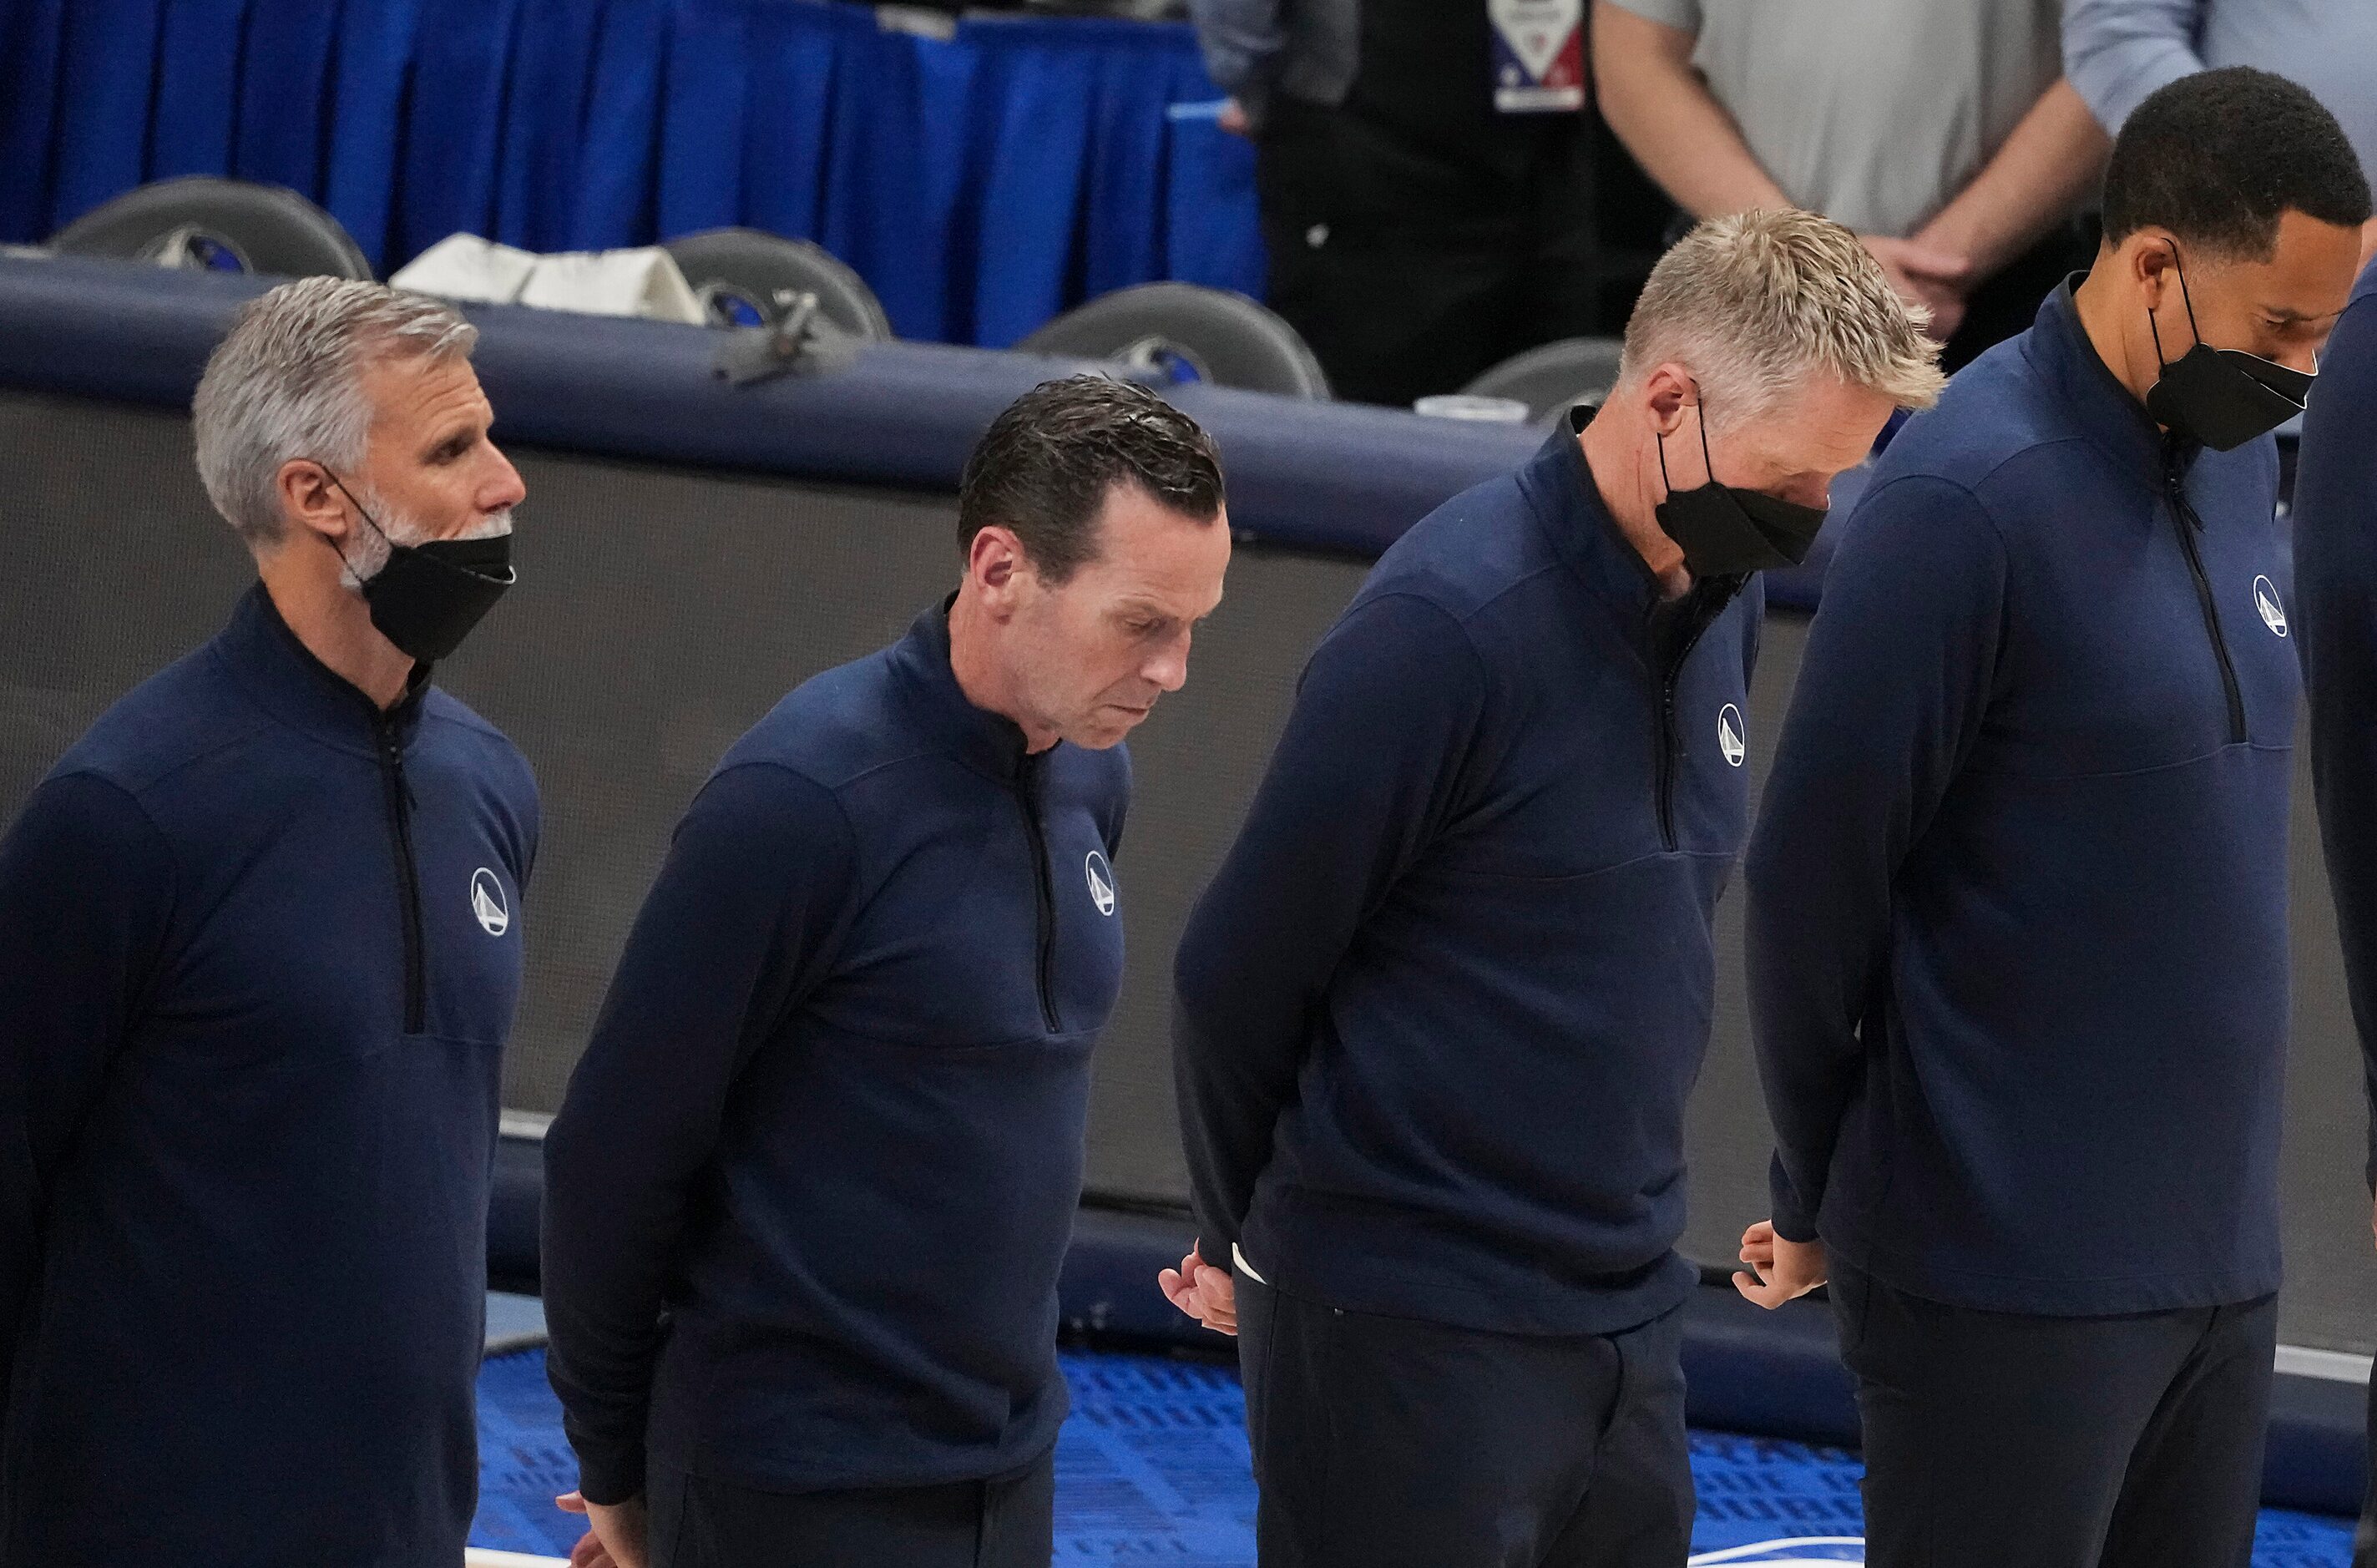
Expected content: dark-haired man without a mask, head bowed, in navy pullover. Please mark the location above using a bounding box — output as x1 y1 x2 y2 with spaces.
544 376 1229 1568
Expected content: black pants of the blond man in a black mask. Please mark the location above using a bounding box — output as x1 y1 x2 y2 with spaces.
1238 1276 1692 1568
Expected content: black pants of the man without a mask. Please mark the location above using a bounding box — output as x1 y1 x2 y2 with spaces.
649 1452 1055 1568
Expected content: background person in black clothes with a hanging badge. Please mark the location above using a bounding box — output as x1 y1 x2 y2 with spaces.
1189 0 1609 407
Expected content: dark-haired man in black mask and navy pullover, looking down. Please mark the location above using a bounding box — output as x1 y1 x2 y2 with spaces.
1735 67 2369 1568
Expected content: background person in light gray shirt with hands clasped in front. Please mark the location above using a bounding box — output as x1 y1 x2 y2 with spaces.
1592 0 2111 368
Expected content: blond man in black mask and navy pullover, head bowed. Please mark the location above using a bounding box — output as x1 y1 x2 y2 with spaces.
1162 211 1940 1568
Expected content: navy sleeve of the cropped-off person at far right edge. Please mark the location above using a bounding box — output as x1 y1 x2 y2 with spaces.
2294 269 2377 1183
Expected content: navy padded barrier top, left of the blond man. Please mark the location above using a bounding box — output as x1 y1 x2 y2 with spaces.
0 256 1543 556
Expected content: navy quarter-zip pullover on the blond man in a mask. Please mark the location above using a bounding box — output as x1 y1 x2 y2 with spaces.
1174 413 1762 1333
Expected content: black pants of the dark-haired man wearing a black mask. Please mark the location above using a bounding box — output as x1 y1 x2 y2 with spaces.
1833 1262 2277 1568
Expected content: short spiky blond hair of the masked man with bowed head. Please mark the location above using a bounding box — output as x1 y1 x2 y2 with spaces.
1619 207 1947 425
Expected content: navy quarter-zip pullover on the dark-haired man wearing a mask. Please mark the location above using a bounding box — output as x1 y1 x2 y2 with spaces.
1747 285 2299 1316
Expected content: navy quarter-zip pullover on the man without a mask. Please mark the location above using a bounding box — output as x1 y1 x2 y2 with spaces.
544 606 1129 1504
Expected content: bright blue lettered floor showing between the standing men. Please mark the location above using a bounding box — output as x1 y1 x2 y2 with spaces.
471 1349 2354 1568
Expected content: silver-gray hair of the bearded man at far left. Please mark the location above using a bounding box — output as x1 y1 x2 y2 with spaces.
190 278 478 551
